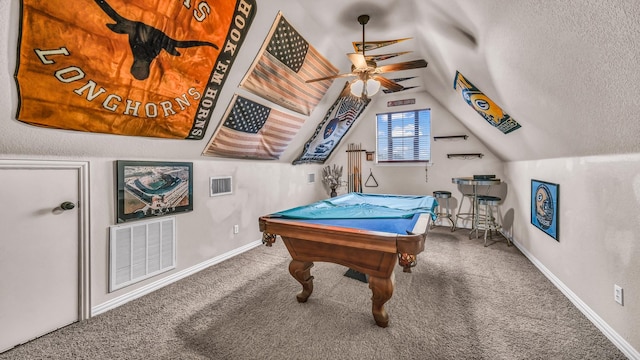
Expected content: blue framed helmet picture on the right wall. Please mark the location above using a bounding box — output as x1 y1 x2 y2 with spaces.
531 179 560 241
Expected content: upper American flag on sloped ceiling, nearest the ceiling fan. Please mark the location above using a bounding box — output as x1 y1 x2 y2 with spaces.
240 13 338 115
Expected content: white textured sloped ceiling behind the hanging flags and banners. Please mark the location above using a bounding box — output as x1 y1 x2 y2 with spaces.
0 0 640 162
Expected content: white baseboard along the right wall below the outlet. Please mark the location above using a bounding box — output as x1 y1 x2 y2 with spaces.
503 233 640 360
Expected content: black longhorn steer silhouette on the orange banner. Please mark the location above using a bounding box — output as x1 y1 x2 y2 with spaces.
95 0 218 80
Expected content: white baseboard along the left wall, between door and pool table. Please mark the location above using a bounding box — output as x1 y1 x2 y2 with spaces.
91 240 262 316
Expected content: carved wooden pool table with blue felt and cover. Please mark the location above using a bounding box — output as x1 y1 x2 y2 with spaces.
259 193 437 327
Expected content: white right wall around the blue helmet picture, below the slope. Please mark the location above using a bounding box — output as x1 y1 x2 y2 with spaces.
502 153 640 356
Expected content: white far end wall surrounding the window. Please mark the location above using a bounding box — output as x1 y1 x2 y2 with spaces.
327 89 504 207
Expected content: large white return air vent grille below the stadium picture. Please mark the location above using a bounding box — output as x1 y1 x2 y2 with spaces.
109 217 176 292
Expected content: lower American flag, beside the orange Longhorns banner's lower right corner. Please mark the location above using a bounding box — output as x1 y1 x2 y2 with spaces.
203 95 304 159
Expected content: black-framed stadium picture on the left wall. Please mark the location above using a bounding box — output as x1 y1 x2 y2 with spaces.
116 160 193 223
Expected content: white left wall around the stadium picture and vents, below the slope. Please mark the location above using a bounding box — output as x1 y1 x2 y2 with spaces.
90 158 324 307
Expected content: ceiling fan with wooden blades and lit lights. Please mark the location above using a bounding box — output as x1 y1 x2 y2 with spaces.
306 15 427 99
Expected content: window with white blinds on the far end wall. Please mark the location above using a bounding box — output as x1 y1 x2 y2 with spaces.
376 109 431 163
